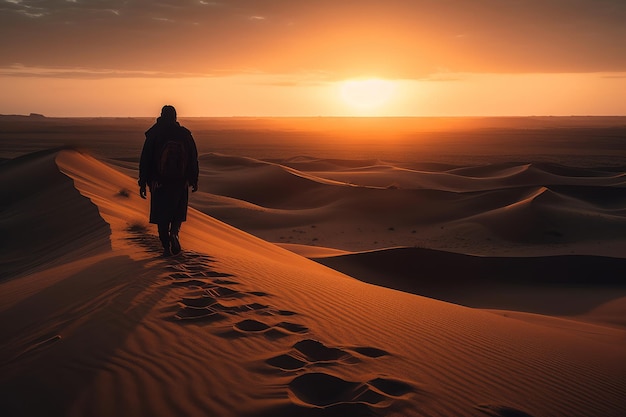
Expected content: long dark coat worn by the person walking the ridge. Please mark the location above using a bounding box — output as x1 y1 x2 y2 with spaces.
139 117 199 224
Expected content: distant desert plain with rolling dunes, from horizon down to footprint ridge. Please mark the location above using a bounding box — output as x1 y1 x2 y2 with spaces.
6 117 626 257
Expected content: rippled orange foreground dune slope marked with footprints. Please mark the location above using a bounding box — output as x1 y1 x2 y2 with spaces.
0 151 626 417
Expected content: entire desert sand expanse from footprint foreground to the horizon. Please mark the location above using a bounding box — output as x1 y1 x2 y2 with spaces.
0 118 626 417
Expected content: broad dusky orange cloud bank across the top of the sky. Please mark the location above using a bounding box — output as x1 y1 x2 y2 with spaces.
0 0 626 78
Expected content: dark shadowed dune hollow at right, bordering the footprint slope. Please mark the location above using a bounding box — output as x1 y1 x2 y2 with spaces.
311 248 626 318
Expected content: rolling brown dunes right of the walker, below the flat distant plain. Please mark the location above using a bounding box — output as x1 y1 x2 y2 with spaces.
180 154 626 257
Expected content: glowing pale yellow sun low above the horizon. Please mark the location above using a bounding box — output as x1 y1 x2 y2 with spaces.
339 78 395 110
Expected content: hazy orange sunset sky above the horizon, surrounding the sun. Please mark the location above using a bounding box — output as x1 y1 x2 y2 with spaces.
0 0 626 116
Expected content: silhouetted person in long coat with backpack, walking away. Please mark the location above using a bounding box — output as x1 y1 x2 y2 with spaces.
139 105 198 256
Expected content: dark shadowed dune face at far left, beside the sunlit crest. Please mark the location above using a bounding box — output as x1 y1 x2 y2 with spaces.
0 146 110 280
